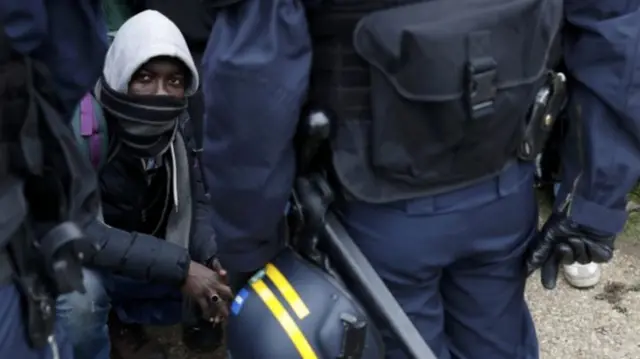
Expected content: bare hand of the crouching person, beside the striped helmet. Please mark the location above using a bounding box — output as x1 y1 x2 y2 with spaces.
181 261 233 322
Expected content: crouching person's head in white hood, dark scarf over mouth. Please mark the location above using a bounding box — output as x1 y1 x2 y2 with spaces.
95 10 199 158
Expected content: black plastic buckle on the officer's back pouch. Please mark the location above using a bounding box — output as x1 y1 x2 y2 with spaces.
466 57 498 120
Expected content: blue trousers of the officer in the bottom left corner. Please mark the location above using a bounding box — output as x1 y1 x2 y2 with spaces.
0 285 73 359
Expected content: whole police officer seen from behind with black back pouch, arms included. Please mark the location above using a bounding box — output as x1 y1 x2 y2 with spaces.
204 0 640 359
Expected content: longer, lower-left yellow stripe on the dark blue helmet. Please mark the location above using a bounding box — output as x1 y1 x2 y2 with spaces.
251 279 318 359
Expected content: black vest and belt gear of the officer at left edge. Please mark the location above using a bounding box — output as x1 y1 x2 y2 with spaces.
0 30 98 348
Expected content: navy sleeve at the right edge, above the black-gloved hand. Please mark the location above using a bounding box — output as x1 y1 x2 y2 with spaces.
556 0 640 234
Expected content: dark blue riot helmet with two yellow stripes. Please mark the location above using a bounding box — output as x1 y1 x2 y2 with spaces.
227 249 384 359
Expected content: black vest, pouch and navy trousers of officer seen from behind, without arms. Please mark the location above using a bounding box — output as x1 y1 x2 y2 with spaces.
302 0 562 359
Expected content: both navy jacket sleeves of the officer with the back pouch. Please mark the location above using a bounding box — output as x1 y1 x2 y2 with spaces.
203 0 640 270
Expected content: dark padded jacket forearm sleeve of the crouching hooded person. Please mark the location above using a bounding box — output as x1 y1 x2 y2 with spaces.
85 219 190 285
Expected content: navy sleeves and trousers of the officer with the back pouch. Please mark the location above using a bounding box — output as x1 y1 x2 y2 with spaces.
203 0 640 359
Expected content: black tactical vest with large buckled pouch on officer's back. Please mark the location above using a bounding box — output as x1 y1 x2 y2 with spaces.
309 0 565 203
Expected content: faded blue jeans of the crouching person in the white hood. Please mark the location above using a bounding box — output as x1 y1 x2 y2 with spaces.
57 270 182 359
